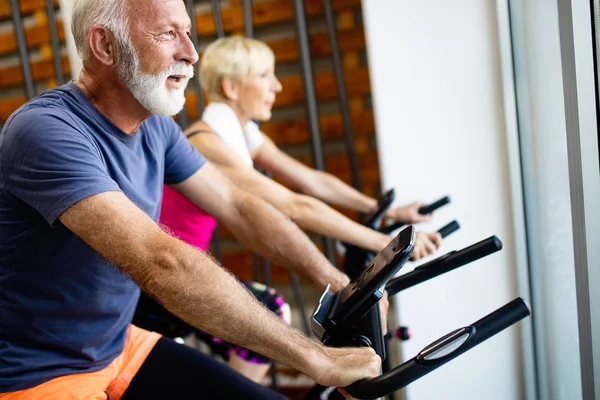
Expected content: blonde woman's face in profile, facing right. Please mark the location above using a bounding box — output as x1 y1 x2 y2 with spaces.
236 64 281 121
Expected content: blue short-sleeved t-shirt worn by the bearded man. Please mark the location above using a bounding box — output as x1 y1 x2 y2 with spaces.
0 83 205 392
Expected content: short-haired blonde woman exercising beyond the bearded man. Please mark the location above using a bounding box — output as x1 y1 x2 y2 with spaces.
173 36 441 259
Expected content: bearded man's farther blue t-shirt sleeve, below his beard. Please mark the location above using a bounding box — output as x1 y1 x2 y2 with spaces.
163 117 206 184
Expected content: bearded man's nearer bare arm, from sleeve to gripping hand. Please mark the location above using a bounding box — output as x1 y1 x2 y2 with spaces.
60 192 378 386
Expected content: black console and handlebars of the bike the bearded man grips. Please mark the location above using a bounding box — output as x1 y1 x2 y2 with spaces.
305 226 530 399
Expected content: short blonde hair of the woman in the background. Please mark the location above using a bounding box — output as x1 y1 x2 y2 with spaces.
200 36 275 101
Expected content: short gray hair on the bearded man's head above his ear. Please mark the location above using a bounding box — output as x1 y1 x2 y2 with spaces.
71 0 129 61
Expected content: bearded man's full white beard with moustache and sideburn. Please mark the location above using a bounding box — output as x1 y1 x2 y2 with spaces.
118 37 194 116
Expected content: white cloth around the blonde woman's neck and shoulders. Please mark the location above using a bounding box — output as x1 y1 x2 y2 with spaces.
202 103 265 165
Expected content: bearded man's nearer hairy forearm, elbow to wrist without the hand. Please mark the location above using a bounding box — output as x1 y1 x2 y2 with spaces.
139 234 317 372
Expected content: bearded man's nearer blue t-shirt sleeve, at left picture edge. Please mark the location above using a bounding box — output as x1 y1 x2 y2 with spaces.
0 107 121 225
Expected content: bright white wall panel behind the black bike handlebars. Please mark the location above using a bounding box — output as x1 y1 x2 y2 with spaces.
363 0 524 400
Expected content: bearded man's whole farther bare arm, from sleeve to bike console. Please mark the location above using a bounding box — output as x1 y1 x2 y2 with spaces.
173 163 349 290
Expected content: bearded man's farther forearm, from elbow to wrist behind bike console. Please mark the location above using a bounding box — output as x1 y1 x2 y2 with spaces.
222 190 347 289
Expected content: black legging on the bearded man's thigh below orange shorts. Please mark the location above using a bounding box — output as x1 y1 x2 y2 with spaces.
122 337 285 400
